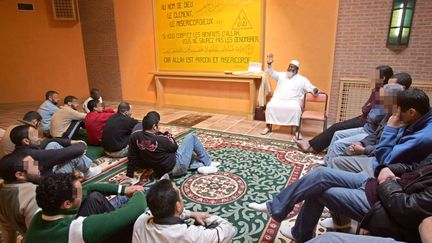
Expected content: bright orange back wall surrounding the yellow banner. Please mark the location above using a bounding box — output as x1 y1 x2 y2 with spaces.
115 0 338 110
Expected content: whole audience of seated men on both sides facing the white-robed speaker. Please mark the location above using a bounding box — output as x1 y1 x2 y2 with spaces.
0 61 432 242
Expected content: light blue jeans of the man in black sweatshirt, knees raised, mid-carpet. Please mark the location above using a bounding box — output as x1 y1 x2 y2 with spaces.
172 133 211 176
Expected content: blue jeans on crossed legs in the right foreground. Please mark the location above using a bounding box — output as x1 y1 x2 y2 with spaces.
267 167 370 242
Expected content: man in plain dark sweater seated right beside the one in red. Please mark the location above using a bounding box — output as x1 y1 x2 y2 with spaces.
101 102 138 158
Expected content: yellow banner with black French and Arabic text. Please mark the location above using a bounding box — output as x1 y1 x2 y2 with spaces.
154 0 263 71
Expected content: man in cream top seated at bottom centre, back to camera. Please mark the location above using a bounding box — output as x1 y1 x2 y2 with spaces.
132 179 236 243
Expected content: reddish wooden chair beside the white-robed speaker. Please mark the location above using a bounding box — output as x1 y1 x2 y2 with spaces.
296 92 328 139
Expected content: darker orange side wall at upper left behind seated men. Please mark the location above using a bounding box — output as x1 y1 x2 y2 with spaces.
0 0 88 103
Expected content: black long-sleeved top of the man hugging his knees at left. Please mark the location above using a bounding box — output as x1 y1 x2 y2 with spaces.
13 138 87 174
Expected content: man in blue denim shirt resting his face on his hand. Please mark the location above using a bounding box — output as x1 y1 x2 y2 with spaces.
329 88 432 175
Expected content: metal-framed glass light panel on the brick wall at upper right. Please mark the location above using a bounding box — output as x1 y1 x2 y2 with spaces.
387 0 415 47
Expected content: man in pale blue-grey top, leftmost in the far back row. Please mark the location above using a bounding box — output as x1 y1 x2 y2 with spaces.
38 90 60 137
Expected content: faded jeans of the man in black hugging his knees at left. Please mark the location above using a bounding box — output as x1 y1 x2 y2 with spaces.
45 142 93 173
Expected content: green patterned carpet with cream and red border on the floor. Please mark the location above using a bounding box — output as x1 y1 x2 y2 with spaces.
86 125 319 242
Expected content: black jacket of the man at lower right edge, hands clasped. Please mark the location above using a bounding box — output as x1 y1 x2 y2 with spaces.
360 154 432 242
